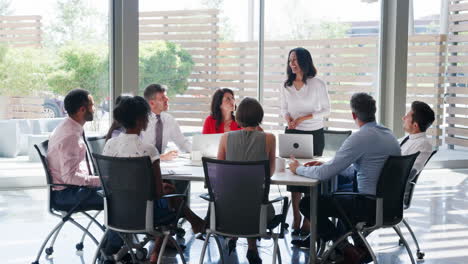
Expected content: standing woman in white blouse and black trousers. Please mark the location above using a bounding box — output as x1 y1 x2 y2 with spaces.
280 47 330 235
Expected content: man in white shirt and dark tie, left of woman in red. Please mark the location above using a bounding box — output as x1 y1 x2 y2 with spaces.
141 84 192 161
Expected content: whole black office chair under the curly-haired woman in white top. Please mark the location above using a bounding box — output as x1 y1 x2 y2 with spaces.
92 153 185 263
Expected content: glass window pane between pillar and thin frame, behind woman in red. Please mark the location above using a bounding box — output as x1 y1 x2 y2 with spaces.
139 0 258 133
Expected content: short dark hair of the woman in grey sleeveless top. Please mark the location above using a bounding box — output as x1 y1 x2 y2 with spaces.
236 97 263 127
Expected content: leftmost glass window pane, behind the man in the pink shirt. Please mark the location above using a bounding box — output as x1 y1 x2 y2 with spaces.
0 0 110 186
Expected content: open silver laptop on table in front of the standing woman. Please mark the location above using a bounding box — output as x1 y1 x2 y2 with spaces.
278 134 314 159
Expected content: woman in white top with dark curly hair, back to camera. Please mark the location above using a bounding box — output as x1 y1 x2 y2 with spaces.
103 96 205 263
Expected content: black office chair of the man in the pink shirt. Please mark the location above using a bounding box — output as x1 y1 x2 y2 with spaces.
33 140 104 264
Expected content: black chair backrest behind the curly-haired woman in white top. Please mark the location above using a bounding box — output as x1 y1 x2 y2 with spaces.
93 153 156 232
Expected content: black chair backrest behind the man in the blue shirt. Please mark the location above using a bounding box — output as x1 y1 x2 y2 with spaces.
376 152 419 225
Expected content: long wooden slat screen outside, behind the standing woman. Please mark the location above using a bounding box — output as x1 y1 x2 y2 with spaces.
140 10 446 145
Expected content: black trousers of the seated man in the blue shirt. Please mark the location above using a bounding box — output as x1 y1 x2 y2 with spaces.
299 195 375 241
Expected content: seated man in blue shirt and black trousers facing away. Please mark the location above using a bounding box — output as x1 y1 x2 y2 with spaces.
289 93 400 263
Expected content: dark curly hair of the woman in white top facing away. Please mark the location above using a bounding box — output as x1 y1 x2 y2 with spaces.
113 96 151 129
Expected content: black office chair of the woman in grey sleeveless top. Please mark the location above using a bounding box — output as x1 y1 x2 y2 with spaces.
200 158 288 263
